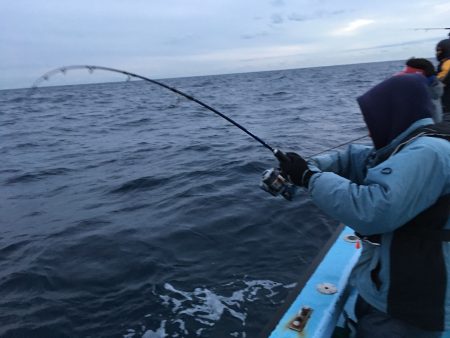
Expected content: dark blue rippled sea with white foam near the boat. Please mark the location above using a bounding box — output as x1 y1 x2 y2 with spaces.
0 61 403 338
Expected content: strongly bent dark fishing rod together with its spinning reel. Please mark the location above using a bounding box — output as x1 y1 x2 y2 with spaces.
31 65 367 200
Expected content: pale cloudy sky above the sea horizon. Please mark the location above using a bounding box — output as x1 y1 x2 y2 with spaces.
0 0 450 89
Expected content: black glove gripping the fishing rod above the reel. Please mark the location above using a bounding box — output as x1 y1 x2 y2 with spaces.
277 153 314 188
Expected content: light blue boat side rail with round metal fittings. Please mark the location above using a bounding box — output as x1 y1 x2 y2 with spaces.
262 224 450 338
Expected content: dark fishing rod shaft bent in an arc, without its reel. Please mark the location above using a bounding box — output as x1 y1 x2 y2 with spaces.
31 65 367 160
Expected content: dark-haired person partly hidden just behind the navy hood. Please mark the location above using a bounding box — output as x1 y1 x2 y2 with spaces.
396 58 444 123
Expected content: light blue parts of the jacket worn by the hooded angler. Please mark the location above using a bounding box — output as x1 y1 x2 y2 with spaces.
308 118 450 329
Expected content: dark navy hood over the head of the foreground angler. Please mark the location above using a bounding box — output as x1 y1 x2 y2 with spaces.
357 74 432 150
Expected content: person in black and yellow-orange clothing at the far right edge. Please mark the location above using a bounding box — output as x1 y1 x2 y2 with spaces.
436 38 450 123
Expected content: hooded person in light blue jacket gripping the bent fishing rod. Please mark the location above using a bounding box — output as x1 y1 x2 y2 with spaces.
280 74 450 338
